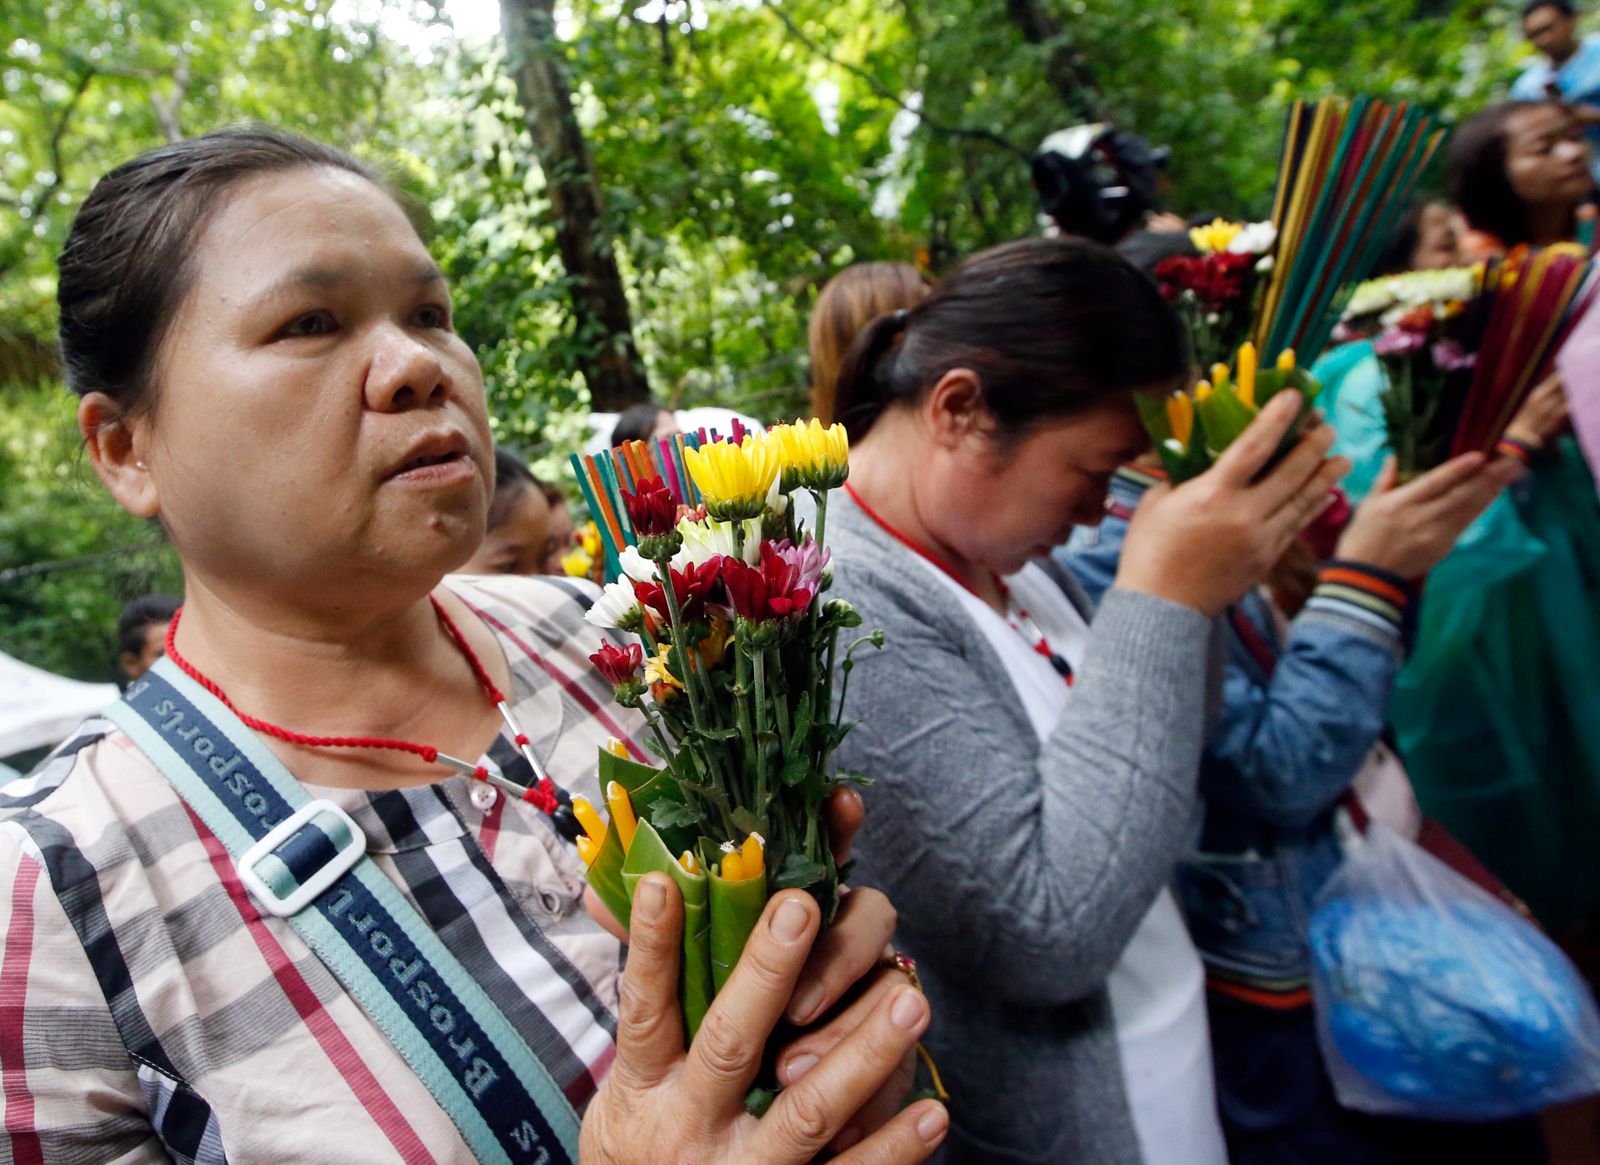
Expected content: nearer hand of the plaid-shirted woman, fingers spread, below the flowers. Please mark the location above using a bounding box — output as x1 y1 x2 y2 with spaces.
579 874 949 1165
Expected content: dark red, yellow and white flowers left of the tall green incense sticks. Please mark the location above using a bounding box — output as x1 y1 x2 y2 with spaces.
1155 219 1278 368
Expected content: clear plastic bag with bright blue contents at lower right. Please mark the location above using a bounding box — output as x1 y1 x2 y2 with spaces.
1310 824 1600 1120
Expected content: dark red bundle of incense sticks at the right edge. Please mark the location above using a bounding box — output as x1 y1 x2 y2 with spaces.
1451 246 1597 454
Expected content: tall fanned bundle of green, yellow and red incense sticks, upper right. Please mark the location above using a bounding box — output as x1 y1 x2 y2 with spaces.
1253 98 1445 366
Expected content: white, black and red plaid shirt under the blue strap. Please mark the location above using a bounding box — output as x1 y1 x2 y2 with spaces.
0 578 642 1165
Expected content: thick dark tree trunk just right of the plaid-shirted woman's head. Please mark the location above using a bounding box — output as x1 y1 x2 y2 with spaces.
501 0 650 411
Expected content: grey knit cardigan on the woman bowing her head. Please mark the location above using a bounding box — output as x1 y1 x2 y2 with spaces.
827 490 1211 1165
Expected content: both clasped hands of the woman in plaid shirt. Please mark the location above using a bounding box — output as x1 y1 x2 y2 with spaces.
579 795 949 1165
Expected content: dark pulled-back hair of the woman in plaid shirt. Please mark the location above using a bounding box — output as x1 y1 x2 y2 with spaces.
56 125 398 414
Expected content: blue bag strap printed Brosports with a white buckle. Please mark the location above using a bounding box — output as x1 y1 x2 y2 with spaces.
106 659 579 1165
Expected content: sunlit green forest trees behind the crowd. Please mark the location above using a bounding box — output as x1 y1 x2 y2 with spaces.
0 0 1528 680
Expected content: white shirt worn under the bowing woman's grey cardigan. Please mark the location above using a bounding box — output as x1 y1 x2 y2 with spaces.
925 563 1227 1165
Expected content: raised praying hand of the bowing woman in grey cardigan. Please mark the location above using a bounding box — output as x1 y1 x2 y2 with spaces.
1117 392 1350 616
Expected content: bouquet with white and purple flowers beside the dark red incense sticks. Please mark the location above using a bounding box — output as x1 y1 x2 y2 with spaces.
1336 264 1485 482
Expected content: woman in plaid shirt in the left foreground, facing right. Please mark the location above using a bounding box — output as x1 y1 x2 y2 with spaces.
0 130 946 1165
